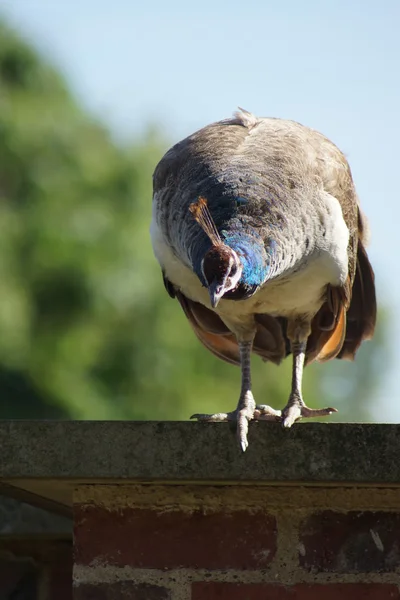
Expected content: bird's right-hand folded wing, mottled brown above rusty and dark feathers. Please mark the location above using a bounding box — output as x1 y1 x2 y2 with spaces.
307 132 376 362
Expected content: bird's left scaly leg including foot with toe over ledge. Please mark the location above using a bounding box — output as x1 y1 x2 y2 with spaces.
190 342 281 452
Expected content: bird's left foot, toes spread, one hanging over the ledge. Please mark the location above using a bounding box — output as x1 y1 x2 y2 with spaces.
190 392 281 452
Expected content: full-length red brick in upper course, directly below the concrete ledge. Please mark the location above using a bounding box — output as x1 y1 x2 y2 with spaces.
75 506 277 569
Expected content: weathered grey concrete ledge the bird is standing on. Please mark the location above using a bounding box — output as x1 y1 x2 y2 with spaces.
0 421 400 485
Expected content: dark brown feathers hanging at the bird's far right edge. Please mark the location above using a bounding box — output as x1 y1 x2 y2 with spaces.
337 241 376 360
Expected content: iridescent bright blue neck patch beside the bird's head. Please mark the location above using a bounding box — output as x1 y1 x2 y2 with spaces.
222 231 271 287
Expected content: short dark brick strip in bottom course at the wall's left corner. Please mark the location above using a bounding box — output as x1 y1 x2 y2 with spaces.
74 581 171 600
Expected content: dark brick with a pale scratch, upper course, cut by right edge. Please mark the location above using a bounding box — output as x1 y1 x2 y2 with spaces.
299 511 400 573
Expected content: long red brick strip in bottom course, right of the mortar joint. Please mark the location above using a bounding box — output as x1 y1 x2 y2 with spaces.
192 582 400 600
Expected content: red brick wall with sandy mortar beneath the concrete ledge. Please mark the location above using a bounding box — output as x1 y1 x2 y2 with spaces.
74 483 400 600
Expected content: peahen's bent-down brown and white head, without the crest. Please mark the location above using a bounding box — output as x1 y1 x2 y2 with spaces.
201 243 243 308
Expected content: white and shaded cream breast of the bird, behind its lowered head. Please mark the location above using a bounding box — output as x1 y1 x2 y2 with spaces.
151 194 349 321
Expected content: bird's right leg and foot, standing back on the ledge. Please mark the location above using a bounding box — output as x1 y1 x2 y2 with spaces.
282 323 337 427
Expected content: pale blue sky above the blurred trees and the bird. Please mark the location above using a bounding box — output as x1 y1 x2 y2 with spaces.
0 0 400 421
